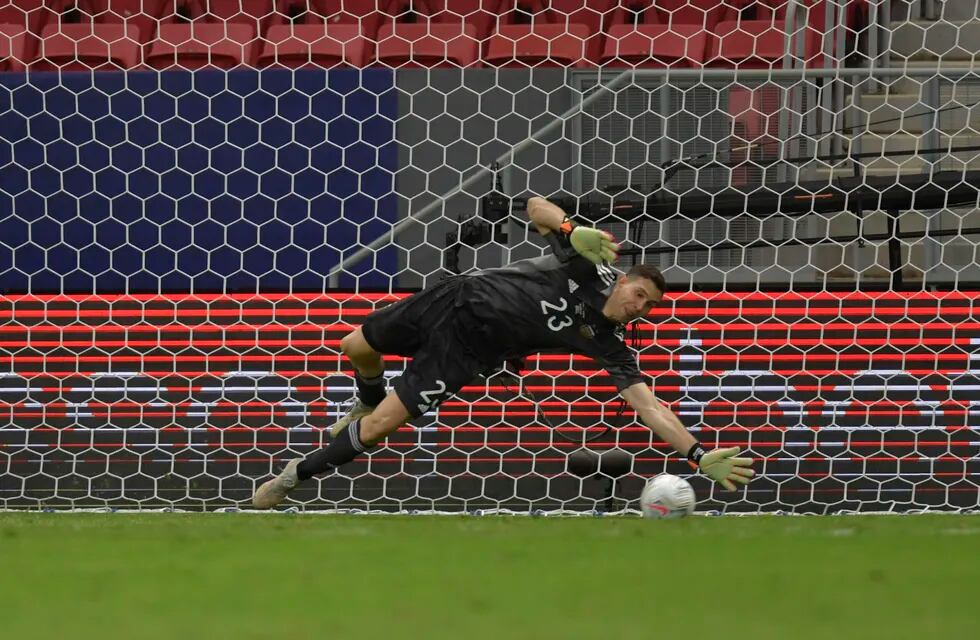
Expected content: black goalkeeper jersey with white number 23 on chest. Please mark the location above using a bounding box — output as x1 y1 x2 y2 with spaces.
460 239 646 391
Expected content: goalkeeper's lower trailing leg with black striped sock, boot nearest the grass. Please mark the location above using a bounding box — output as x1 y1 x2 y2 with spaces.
252 391 411 509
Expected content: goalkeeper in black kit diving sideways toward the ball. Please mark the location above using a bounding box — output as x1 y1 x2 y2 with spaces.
252 198 754 509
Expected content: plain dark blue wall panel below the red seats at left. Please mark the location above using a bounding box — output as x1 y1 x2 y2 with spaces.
0 69 398 293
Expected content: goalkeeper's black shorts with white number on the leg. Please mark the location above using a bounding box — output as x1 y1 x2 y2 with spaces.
361 278 496 418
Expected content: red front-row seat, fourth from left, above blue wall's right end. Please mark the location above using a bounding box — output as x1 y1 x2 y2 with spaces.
257 23 373 68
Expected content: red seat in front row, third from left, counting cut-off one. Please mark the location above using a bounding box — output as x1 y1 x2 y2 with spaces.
145 20 257 69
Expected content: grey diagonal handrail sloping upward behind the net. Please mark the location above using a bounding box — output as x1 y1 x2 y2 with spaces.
328 69 633 288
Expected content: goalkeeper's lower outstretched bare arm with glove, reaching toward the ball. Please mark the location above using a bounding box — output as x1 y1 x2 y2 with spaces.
623 383 755 491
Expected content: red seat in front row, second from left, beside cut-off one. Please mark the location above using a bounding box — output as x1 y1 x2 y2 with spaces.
31 22 141 71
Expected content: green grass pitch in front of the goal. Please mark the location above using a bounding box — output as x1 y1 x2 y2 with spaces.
0 513 980 640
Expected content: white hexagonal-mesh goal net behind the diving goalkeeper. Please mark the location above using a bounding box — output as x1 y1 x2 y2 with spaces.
0 0 980 513
